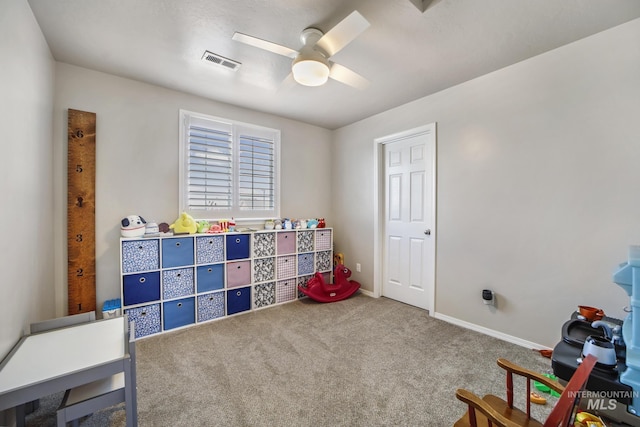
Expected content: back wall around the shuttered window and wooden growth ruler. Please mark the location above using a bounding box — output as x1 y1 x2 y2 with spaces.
53 63 331 315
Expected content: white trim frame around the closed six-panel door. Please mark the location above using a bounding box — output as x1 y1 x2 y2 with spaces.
373 122 438 316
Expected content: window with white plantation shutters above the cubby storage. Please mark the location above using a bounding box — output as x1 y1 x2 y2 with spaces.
180 111 280 220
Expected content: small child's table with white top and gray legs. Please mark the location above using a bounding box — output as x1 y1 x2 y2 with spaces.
0 317 137 427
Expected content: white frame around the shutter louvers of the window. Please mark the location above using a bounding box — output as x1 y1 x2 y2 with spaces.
178 109 281 222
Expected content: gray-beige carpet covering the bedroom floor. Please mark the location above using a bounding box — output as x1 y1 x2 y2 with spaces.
27 294 555 427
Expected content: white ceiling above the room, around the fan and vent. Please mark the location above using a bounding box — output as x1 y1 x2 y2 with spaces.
28 0 640 129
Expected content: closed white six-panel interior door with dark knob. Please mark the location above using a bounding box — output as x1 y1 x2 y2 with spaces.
382 125 435 310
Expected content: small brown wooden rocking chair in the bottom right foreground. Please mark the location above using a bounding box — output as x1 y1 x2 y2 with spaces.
454 355 596 427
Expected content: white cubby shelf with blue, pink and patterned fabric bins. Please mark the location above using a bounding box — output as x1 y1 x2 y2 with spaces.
120 228 333 338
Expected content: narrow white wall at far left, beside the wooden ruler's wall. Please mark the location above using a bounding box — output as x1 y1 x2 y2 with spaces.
0 0 54 359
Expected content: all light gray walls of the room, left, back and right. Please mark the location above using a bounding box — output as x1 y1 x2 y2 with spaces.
5 0 640 354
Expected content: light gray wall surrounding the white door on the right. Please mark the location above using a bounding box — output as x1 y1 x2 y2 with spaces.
333 20 640 346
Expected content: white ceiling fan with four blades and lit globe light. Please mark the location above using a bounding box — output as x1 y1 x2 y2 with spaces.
232 11 370 89
